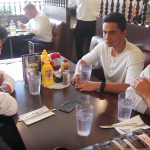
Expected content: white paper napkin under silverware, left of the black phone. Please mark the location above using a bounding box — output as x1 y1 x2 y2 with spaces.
19 106 55 125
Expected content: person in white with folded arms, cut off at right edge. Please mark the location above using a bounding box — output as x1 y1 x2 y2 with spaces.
126 65 150 116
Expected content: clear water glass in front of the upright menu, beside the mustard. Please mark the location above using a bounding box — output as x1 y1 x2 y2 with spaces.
28 70 41 95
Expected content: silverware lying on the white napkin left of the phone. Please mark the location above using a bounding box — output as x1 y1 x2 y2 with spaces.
18 109 56 122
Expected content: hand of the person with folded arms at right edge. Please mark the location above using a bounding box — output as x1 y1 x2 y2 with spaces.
131 77 150 99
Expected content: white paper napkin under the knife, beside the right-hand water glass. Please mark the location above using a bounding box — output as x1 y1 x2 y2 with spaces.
115 115 150 135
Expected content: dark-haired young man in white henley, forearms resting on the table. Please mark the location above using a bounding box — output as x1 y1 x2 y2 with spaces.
72 12 144 93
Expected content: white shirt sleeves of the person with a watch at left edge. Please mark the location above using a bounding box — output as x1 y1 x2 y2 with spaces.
0 71 17 116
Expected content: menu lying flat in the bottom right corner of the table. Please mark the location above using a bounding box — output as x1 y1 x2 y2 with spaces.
81 128 150 150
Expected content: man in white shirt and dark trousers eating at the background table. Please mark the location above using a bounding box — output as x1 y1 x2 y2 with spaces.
15 4 53 54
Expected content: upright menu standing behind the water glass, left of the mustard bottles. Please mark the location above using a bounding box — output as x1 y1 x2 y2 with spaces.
21 53 41 87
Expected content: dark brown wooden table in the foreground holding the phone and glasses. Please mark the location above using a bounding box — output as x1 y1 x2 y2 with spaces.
1 57 150 150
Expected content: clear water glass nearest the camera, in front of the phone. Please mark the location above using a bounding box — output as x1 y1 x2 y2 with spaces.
76 103 94 137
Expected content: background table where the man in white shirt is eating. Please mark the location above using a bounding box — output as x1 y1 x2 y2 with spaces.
7 32 34 58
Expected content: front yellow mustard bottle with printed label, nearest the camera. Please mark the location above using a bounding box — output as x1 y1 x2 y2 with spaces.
41 58 54 86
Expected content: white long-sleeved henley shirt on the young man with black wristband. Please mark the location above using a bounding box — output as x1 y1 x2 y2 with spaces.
82 41 144 84
